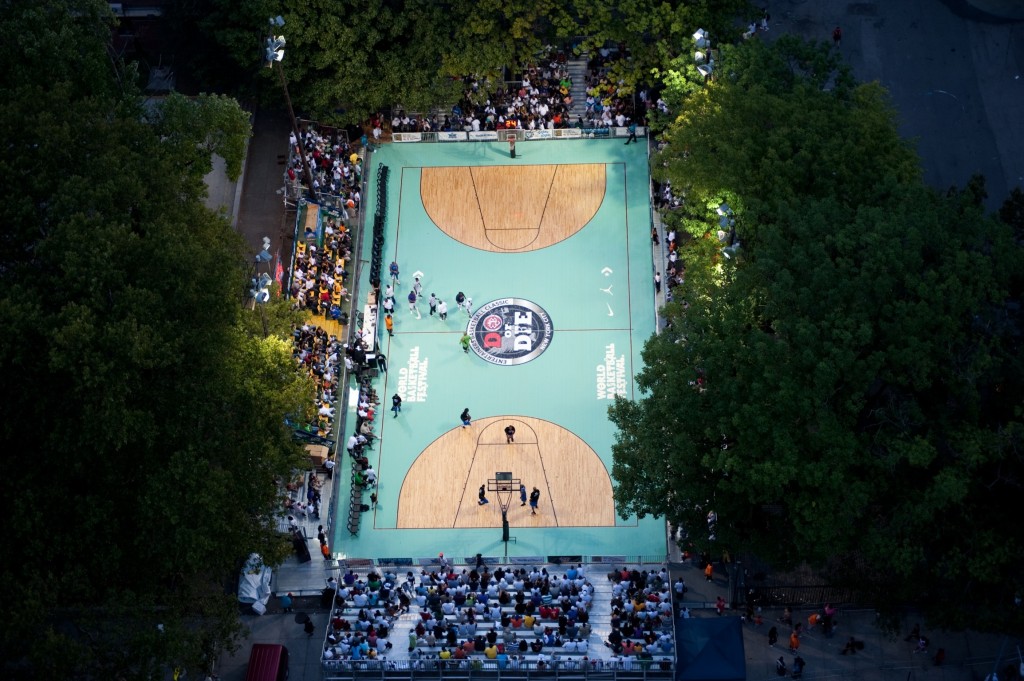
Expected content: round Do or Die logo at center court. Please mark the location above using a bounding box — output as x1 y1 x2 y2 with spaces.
466 298 555 367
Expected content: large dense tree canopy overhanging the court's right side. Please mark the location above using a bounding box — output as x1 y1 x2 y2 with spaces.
611 35 1024 629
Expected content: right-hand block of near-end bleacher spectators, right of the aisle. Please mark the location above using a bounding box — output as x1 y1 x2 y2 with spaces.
604 567 673 656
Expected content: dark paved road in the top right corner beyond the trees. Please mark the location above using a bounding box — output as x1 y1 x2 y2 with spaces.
762 0 1024 209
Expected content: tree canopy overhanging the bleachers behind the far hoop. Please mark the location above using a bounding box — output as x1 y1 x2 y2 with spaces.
190 0 749 123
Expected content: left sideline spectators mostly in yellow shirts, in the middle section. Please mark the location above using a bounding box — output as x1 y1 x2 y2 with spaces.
291 215 352 318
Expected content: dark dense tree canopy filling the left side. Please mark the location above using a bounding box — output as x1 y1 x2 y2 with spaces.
0 0 309 679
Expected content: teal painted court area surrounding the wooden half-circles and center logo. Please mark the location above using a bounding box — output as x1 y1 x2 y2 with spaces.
332 139 666 558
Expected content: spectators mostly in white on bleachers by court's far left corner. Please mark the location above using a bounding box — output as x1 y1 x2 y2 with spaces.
287 126 362 204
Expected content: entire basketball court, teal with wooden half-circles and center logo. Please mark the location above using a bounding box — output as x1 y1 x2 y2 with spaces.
332 139 666 561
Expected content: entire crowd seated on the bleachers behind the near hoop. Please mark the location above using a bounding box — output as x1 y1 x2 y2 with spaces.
324 564 672 670
